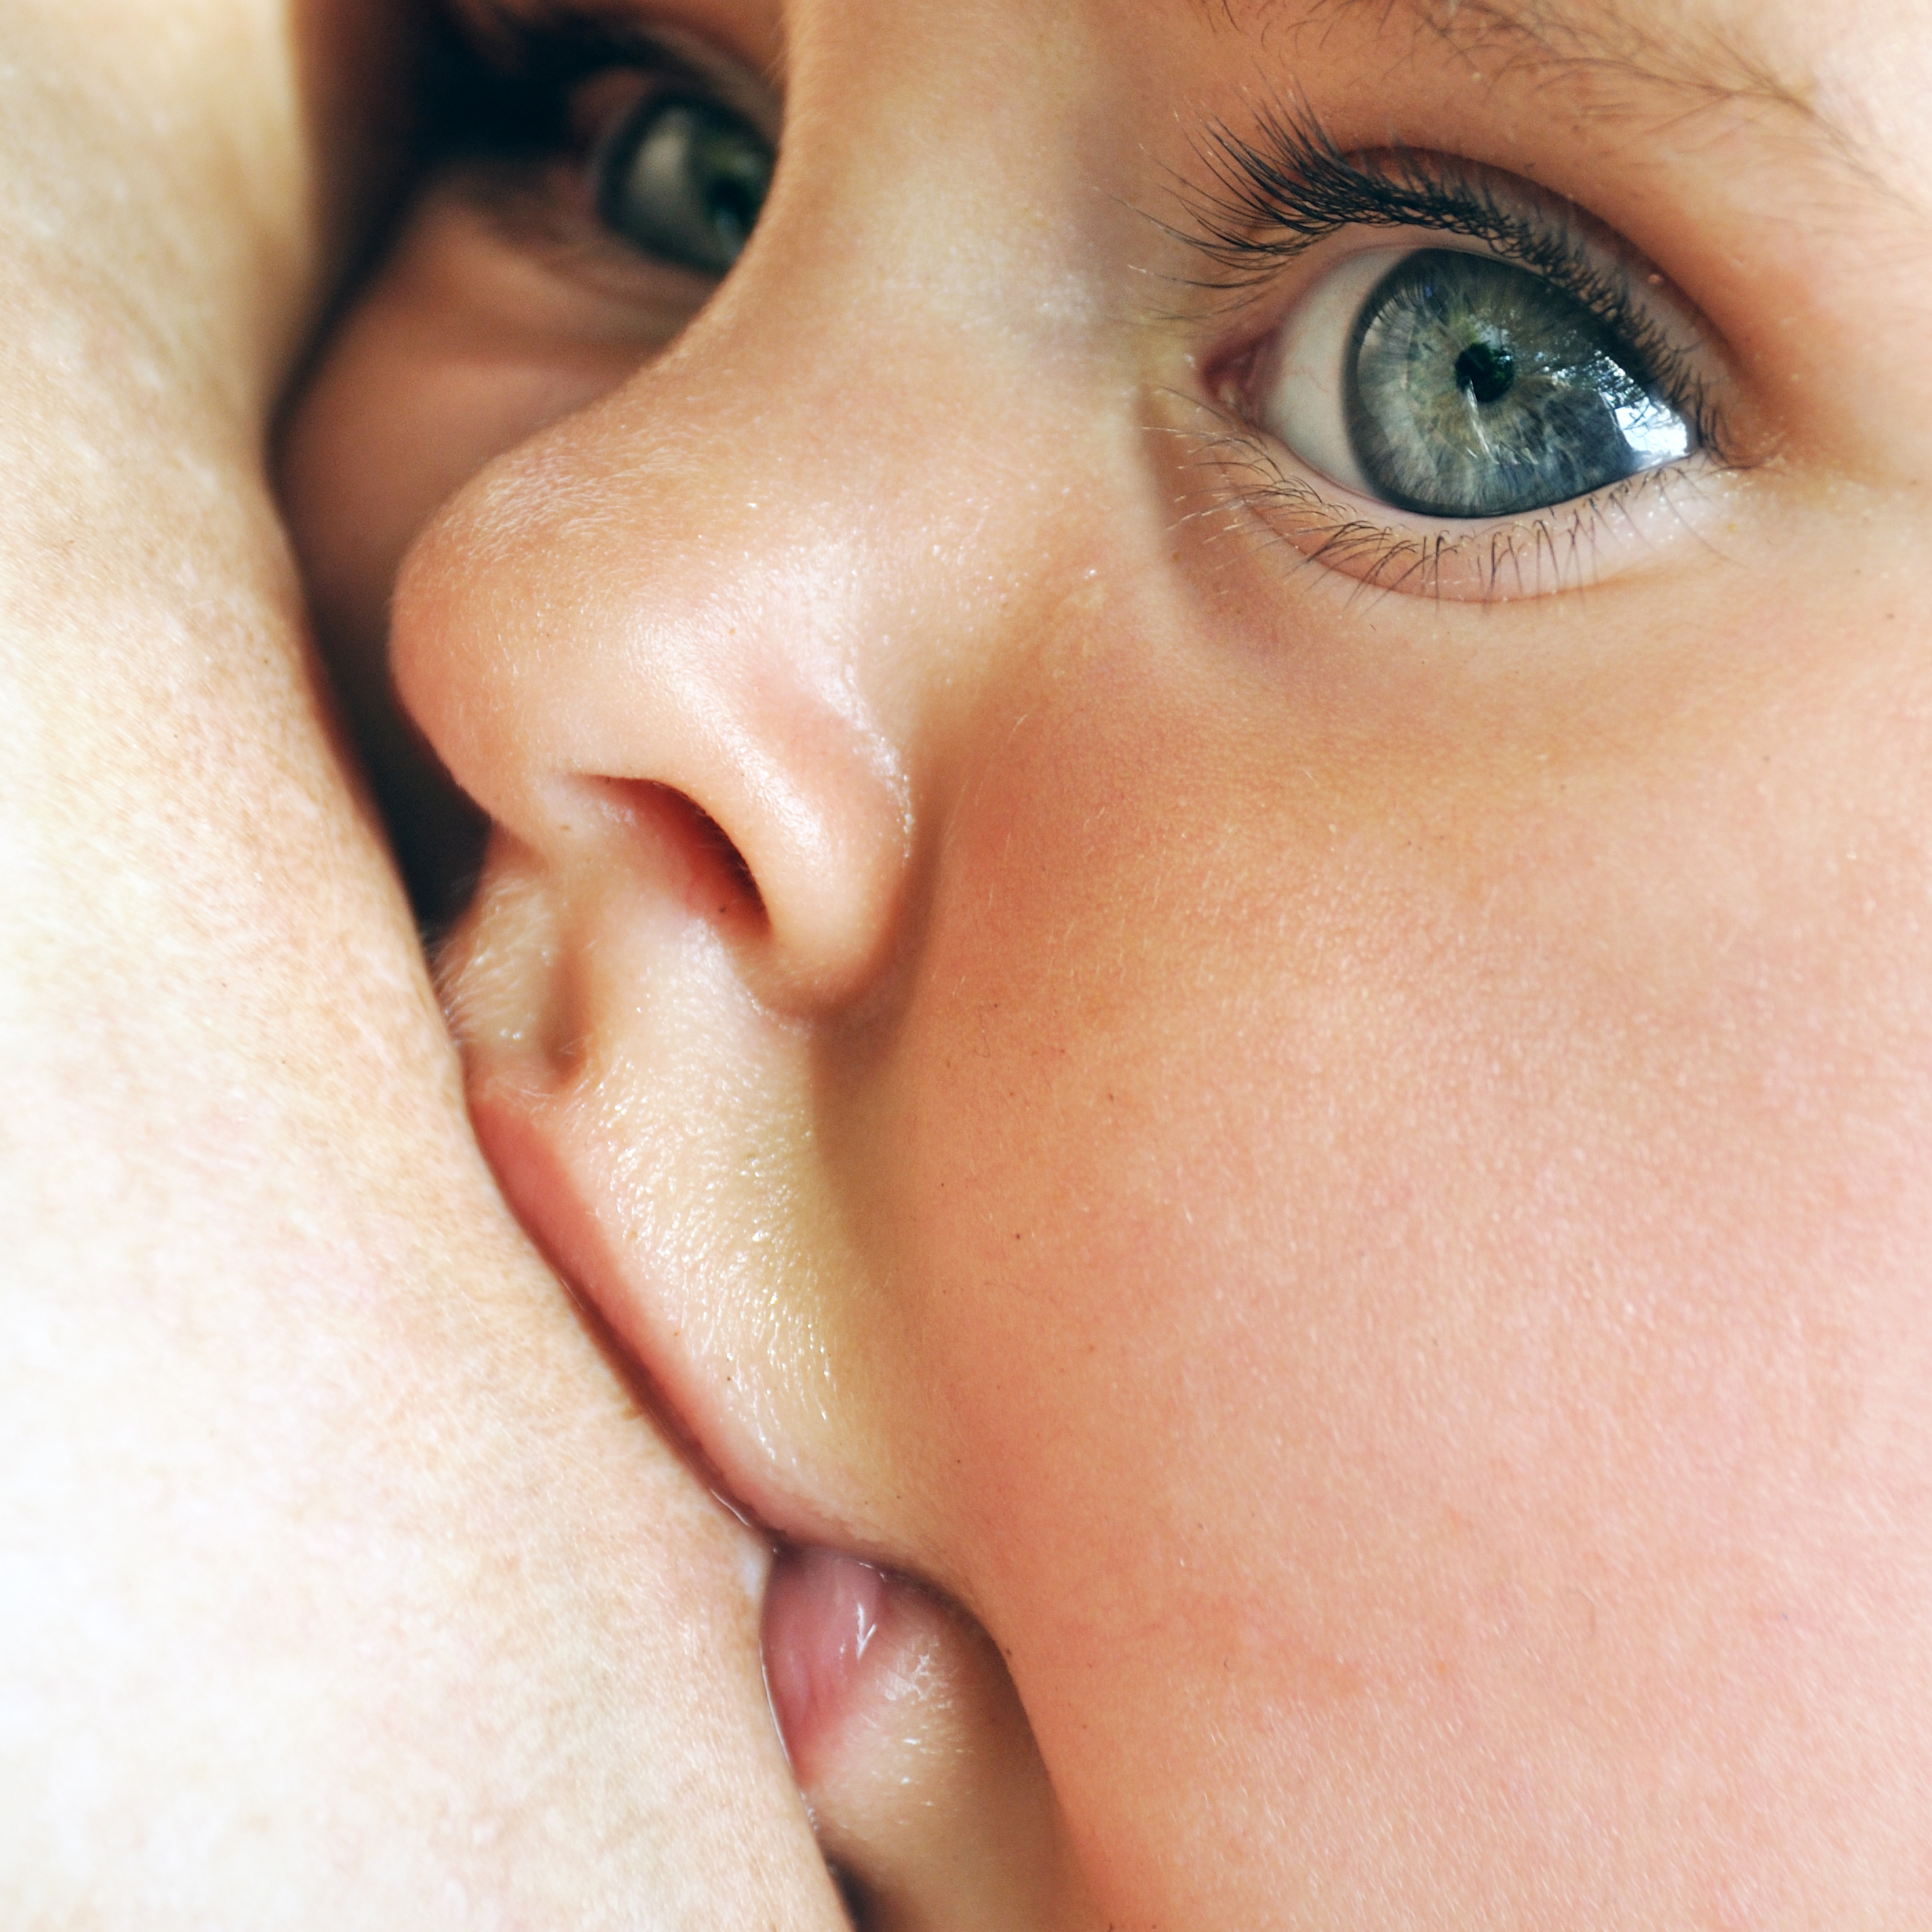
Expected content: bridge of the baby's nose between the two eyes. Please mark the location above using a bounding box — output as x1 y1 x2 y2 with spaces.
601 0 1096 606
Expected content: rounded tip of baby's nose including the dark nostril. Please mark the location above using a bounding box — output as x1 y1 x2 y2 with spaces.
392 406 912 1007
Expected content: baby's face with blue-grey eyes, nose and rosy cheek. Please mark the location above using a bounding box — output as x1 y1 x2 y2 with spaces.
288 0 1932 1932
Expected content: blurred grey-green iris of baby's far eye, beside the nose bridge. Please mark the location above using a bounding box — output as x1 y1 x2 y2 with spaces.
591 95 773 274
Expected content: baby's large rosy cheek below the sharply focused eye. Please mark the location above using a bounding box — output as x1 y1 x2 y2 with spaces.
895 575 1932 1895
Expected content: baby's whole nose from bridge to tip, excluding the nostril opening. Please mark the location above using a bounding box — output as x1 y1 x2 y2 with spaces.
394 11 1120 993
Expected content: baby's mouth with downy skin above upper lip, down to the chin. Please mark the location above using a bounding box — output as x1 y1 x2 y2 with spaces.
442 838 1107 1932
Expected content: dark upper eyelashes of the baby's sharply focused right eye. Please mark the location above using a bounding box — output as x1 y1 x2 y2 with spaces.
1182 108 1722 448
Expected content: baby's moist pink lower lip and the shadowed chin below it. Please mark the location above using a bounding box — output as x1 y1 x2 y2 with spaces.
765 1549 1098 1932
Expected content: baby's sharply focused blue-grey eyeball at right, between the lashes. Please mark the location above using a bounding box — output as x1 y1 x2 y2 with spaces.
1252 246 1698 518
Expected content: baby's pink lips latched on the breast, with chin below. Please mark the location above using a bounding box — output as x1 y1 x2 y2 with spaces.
454 1064 1103 1932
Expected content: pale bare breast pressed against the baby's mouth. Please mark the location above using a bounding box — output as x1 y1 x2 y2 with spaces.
0 0 843 1932
